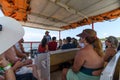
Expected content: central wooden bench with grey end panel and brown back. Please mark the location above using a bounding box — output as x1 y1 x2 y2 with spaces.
34 48 79 79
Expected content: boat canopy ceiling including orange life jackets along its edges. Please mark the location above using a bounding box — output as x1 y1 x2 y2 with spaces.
0 0 120 31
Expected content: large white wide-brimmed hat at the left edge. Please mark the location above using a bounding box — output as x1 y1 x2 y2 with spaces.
0 17 24 54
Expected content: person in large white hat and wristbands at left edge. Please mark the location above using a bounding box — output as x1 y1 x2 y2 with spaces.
0 17 36 80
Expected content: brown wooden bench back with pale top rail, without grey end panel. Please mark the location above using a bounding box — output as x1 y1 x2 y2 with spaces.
49 48 80 72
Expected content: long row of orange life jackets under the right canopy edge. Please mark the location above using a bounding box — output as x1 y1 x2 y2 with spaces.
61 8 120 29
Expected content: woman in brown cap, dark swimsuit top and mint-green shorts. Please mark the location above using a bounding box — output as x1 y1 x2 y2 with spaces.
62 29 104 80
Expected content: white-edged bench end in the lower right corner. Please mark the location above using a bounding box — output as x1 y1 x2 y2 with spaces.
100 51 120 80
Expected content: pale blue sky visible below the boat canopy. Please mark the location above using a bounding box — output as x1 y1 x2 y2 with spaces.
0 11 120 41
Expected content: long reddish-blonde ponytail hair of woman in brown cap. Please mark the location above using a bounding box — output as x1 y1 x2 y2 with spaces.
84 29 103 57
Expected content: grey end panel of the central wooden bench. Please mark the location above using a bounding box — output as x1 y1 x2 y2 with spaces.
35 53 50 80
